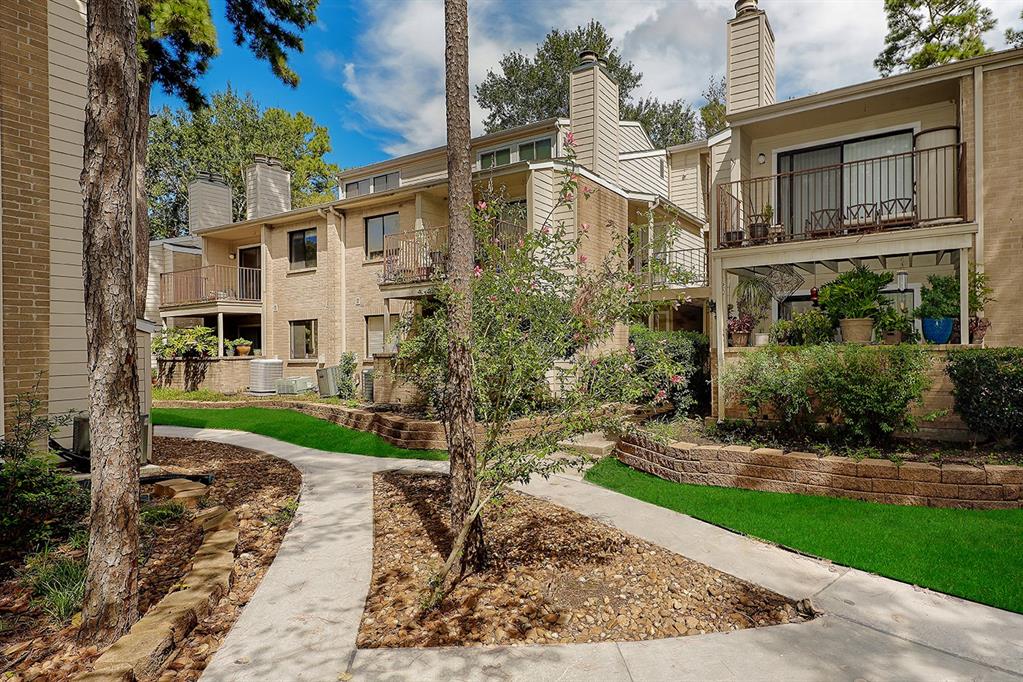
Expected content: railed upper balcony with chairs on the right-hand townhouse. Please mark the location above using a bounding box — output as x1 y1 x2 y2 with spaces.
716 143 966 248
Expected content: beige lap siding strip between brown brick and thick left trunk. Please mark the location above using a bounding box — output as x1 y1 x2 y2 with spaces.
47 0 89 412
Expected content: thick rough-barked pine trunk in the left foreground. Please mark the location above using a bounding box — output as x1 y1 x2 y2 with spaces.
79 0 141 646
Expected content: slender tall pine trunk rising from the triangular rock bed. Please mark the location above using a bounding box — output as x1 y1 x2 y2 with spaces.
444 0 486 574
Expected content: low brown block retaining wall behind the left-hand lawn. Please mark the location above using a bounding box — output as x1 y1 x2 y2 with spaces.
152 399 665 450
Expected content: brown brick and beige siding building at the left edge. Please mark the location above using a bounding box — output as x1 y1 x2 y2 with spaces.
0 0 152 445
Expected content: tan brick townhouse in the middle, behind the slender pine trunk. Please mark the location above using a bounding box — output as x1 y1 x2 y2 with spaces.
160 53 709 400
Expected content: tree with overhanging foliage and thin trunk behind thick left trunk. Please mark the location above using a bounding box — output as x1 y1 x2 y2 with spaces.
134 0 319 317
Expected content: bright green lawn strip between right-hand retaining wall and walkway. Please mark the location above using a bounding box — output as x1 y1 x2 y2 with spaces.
586 458 1023 612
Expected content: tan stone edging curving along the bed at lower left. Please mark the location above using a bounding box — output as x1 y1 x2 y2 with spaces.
75 479 238 682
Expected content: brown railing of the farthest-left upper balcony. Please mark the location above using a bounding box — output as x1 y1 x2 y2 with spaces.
160 265 262 308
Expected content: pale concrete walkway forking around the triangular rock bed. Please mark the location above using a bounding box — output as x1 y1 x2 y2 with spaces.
157 426 1023 682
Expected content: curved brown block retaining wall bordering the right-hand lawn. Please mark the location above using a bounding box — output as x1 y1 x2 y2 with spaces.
615 435 1023 509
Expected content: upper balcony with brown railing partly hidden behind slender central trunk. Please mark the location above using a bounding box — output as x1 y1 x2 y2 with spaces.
381 222 526 284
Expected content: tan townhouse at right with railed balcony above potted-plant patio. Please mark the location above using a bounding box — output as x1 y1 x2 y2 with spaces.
708 0 1023 429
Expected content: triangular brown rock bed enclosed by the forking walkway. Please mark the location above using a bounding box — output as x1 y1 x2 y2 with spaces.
358 471 804 648
